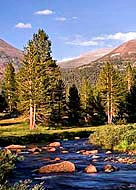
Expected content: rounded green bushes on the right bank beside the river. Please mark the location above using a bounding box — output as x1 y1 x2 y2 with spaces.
89 124 136 151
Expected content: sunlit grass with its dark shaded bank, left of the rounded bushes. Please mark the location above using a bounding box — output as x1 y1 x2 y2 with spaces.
0 118 97 146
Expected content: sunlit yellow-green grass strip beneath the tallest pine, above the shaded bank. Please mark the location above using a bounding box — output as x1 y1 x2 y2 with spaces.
0 118 97 137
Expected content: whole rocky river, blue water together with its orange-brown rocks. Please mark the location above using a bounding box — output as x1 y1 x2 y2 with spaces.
6 138 136 190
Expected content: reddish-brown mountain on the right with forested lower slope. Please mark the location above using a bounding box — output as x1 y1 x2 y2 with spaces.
61 39 136 87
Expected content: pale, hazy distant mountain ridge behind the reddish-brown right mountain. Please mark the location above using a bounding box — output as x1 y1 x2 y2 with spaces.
58 48 113 68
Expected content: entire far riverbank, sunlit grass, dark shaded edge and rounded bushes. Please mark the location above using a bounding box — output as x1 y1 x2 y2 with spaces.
0 118 136 152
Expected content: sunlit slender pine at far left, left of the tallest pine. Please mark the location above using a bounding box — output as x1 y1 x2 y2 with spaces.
2 62 16 112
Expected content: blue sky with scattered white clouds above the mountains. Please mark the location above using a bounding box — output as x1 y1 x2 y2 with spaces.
0 0 136 60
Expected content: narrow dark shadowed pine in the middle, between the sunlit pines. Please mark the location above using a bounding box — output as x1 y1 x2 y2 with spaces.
68 85 81 125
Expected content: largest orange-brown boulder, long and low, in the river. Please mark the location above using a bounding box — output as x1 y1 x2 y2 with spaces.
38 161 75 174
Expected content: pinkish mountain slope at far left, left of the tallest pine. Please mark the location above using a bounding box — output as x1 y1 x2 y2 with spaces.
0 39 23 79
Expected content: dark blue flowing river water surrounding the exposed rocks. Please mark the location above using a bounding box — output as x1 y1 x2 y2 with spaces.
11 139 136 190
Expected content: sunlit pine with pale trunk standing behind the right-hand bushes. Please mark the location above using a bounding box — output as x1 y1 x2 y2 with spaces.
97 62 125 124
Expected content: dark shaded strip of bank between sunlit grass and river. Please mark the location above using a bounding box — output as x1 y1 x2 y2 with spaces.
0 131 92 147
